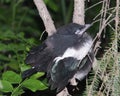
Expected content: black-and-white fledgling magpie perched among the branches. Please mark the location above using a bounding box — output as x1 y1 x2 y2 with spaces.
22 23 94 92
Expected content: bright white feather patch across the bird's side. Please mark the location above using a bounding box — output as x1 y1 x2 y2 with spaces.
54 40 92 62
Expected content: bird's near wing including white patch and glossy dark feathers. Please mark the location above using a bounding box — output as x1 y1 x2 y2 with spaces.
48 33 92 92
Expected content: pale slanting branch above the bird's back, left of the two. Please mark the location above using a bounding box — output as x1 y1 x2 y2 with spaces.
33 0 56 36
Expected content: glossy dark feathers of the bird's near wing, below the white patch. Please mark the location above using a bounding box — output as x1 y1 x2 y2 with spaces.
48 57 79 92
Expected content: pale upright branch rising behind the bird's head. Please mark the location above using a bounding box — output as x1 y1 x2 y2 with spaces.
73 0 85 25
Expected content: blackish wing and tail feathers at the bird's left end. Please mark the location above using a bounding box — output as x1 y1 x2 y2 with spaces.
22 42 54 78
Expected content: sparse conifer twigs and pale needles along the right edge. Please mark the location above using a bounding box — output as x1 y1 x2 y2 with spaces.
84 1 120 96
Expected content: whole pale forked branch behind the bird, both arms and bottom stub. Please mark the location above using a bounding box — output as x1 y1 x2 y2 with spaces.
34 0 85 96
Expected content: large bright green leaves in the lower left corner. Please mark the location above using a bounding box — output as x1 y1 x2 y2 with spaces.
0 71 47 96
